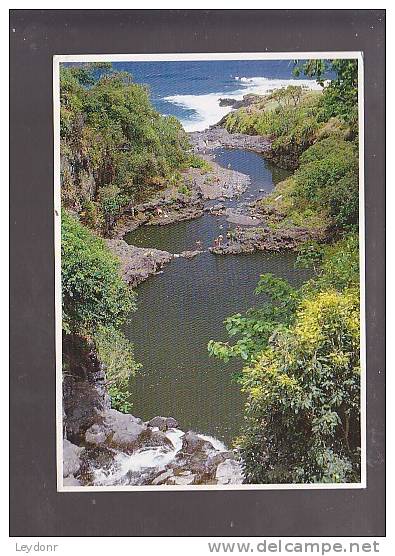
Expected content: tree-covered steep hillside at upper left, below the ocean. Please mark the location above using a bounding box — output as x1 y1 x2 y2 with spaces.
60 64 194 233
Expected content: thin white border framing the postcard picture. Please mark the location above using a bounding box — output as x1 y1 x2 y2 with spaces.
53 51 367 492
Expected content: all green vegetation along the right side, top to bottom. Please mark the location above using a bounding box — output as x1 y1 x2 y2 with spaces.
208 60 360 483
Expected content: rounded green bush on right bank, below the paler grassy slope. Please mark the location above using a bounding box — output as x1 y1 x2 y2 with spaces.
259 135 359 232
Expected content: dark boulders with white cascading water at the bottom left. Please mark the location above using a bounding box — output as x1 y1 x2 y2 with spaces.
63 337 243 486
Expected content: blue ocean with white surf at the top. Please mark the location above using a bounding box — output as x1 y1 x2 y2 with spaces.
95 60 321 131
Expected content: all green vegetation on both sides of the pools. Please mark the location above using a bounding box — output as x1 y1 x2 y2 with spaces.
61 60 360 483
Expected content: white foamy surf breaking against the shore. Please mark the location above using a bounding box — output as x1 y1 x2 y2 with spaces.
163 76 322 131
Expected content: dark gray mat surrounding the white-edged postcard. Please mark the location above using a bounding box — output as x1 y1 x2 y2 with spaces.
10 10 385 536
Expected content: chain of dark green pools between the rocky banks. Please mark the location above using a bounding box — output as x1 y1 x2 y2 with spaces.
126 151 310 444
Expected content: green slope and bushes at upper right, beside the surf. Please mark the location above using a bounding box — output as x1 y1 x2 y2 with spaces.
224 60 359 233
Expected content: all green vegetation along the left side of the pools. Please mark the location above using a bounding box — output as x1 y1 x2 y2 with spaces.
60 63 210 412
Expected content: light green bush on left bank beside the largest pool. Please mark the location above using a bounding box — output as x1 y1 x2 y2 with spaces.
62 210 138 411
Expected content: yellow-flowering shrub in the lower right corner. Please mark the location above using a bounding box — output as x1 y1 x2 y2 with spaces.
241 290 360 483
